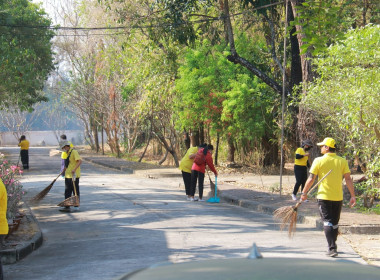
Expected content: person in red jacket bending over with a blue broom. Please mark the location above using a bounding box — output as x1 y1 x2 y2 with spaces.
190 144 218 201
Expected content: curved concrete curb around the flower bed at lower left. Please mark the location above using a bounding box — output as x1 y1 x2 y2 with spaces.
0 204 43 264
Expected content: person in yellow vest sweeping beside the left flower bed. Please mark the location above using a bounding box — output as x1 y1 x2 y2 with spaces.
60 141 82 210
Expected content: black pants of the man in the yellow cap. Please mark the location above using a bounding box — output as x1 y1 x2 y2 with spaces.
318 199 343 250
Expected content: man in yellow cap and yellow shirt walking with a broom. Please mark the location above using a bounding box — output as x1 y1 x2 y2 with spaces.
301 137 356 257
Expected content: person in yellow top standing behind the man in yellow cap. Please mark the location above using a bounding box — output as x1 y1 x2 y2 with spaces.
292 140 313 200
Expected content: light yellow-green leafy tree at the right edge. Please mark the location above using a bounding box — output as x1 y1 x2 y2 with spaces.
302 25 380 201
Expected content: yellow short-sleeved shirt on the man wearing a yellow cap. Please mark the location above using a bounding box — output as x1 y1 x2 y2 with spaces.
310 153 350 201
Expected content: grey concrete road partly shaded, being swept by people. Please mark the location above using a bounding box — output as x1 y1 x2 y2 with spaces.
1 147 365 280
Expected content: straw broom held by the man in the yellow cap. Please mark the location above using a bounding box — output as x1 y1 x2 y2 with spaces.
273 170 332 237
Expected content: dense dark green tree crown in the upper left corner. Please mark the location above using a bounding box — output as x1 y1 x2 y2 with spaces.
0 0 54 109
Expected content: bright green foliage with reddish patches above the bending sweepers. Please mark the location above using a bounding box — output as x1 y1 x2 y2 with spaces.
176 36 275 147
